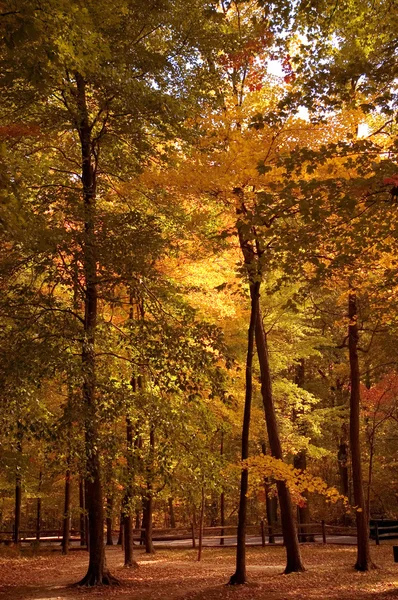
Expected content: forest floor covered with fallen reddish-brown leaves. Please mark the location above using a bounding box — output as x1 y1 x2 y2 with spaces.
0 544 398 600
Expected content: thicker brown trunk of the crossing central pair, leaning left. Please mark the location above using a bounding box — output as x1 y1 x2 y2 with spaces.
256 312 304 574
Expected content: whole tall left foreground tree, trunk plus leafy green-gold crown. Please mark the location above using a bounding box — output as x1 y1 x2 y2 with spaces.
2 0 227 585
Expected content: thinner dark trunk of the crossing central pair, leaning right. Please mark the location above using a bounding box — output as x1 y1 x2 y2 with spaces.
229 283 260 585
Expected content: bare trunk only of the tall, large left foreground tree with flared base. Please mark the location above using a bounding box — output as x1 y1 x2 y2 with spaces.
75 73 116 586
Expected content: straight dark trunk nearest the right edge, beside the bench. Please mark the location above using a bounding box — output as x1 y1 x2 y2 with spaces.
348 287 375 571
